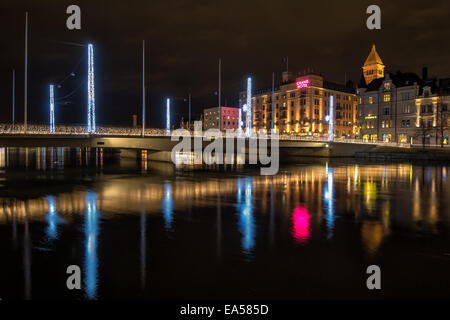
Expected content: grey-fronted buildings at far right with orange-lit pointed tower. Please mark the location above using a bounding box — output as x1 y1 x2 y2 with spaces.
357 46 450 144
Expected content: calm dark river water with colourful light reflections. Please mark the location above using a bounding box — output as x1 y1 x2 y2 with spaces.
0 148 450 300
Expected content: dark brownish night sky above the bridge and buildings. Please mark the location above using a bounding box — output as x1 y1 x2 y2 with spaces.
0 0 450 127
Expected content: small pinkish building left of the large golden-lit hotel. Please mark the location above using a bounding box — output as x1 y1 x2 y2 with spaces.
203 107 239 130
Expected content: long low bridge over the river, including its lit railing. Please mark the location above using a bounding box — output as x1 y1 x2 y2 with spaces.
0 124 386 162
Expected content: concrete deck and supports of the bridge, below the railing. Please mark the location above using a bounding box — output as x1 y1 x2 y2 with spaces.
0 134 384 162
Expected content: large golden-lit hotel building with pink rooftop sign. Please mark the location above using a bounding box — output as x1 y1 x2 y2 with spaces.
239 72 358 137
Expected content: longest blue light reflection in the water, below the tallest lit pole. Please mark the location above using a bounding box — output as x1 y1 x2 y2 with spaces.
84 191 100 299
